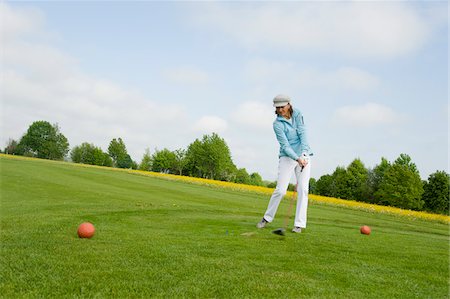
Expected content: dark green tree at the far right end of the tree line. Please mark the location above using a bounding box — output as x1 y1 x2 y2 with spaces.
422 171 450 215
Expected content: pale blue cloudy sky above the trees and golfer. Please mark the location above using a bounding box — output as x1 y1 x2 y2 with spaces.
0 1 449 181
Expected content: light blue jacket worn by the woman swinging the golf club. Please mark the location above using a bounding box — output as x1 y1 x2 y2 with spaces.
273 108 312 160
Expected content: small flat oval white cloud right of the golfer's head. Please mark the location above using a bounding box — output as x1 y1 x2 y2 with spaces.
332 103 405 127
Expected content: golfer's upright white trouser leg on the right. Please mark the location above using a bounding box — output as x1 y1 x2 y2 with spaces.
294 160 311 228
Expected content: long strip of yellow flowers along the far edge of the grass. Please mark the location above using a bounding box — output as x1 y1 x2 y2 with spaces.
0 154 450 224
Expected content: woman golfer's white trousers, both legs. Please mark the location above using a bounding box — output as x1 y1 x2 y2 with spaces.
264 157 311 228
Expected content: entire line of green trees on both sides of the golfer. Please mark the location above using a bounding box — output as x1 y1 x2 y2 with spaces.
4 121 450 214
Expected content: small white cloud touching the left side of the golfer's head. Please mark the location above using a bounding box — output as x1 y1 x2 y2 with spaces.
232 101 275 131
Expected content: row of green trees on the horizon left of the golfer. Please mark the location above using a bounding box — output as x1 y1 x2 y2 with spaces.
4 121 265 186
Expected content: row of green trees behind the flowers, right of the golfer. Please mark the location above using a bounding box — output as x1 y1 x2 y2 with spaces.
310 154 450 215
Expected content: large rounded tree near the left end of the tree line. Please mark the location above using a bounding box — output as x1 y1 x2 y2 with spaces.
17 121 69 160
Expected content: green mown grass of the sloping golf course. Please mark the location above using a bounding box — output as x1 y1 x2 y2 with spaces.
0 156 449 298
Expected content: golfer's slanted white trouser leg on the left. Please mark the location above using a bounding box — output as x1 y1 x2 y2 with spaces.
264 157 298 222
